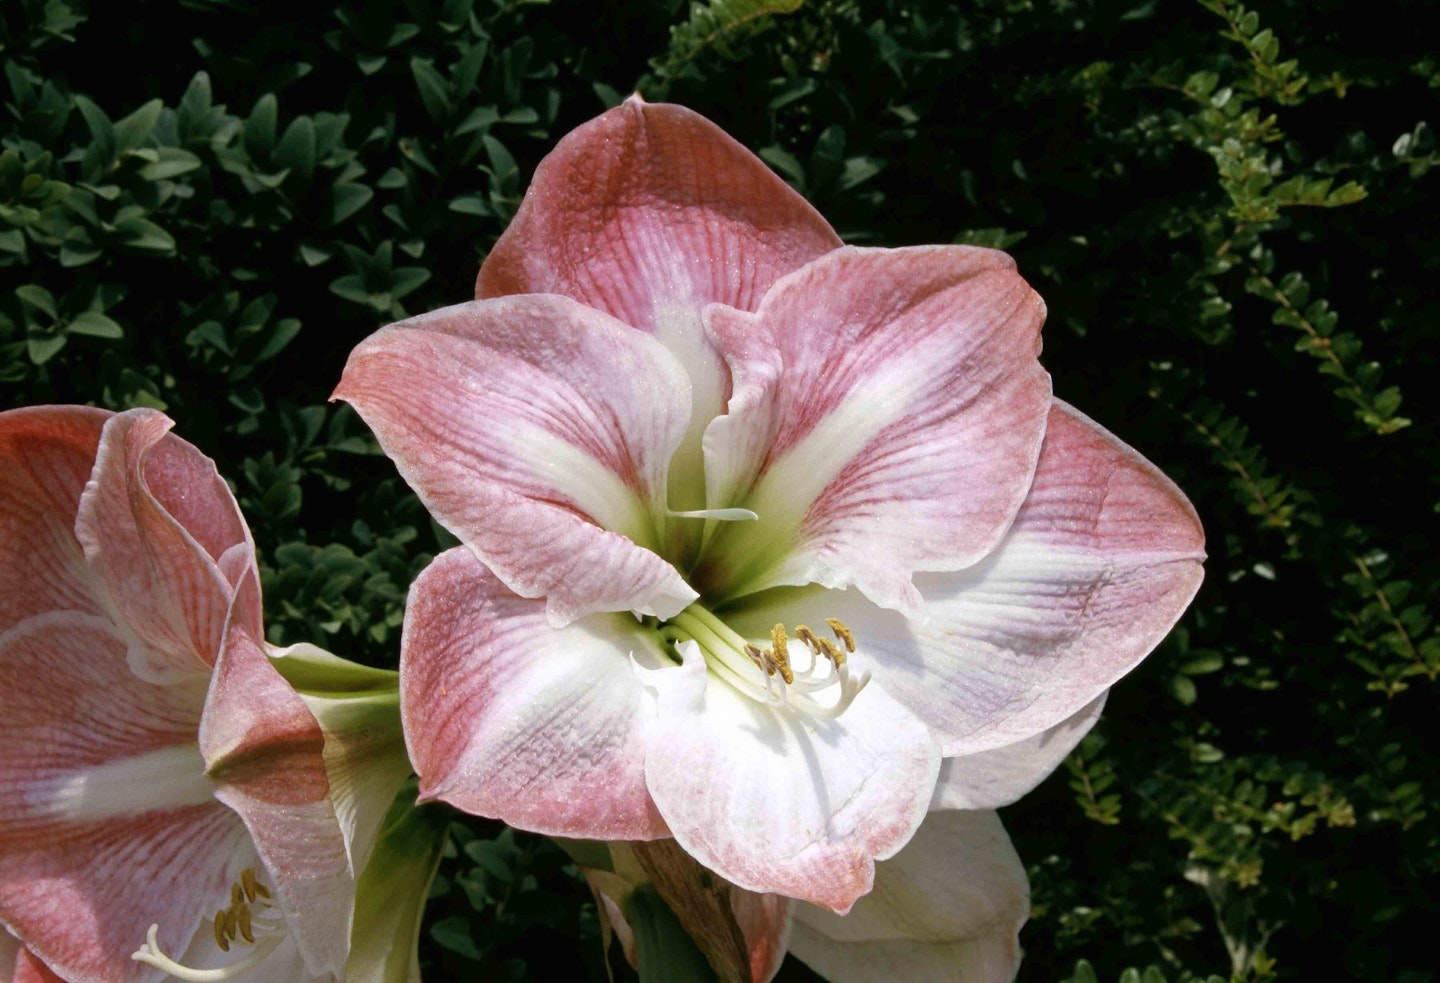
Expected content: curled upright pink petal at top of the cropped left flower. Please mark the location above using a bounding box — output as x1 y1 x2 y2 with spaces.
75 410 259 676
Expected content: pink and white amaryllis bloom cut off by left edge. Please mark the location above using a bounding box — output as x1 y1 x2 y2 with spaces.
0 406 357 983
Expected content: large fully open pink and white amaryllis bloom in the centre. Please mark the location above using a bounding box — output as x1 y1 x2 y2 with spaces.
336 98 1202 911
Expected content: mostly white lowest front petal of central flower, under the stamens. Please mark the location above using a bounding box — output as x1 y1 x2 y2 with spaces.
645 643 940 911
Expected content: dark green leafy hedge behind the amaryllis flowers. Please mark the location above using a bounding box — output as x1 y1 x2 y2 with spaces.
0 0 1440 983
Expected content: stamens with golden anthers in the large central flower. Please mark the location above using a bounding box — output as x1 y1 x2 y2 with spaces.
660 604 870 720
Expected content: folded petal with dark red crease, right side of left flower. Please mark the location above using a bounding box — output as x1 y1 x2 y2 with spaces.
200 623 354 976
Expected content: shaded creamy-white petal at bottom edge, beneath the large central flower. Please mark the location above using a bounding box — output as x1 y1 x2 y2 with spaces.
791 810 1030 983
